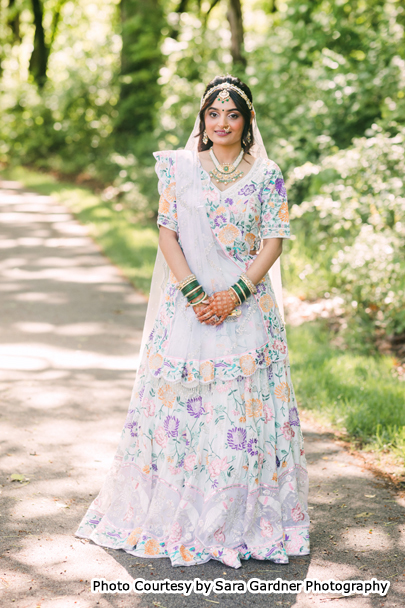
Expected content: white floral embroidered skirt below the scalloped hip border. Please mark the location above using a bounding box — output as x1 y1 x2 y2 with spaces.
76 350 309 568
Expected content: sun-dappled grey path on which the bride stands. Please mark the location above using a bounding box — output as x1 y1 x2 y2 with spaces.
0 182 405 608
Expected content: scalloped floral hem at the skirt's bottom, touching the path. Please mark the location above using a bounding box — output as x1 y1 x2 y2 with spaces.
75 511 309 569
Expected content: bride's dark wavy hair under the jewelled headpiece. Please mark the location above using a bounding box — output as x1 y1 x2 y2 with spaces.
196 76 254 154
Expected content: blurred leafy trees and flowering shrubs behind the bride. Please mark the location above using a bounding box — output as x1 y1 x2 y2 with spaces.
0 0 405 458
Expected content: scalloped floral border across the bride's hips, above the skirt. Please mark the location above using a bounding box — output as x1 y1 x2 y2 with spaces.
147 340 288 387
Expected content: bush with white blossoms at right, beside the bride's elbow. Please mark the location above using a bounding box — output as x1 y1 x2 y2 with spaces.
289 125 405 334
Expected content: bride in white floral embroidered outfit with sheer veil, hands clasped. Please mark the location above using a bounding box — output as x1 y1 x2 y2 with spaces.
76 76 309 568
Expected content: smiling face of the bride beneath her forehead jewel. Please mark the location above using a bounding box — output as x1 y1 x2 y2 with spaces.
205 97 245 146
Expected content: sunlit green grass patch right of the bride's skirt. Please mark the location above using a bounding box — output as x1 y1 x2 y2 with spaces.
288 321 405 458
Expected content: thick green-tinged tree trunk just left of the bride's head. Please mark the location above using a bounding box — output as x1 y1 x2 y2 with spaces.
115 0 163 155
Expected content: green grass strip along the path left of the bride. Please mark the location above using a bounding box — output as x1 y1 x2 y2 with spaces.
1 167 158 294
